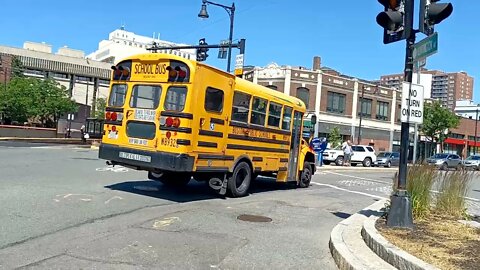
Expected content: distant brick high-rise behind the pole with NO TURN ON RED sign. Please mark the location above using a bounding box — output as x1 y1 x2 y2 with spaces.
380 70 474 110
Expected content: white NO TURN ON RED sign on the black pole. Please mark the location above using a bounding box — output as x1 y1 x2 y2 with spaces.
400 82 423 124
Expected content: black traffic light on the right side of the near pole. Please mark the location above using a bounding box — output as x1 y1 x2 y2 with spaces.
418 0 453 36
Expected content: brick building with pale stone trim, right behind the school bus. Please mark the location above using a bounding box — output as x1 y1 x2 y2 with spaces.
244 57 413 151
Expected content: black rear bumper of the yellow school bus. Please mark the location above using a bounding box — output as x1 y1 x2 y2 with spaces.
98 143 194 172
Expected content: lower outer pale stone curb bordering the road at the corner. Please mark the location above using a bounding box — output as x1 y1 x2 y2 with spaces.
329 199 395 270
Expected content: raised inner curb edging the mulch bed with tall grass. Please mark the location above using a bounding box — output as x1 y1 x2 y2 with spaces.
362 216 440 270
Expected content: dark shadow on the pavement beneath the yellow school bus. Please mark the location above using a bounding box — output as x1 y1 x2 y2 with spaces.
105 177 295 202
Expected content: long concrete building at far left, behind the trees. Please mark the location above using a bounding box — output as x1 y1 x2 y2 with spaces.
0 42 111 128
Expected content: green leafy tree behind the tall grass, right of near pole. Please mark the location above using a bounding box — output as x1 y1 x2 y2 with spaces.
421 101 460 152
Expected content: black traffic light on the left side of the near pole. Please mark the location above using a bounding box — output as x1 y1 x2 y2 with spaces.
377 0 412 44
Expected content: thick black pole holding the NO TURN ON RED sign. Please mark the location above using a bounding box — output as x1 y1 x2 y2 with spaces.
387 0 415 228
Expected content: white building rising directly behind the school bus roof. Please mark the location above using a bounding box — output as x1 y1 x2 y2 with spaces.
87 27 196 63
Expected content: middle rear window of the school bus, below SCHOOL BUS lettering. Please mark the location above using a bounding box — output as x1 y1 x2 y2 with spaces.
130 85 162 109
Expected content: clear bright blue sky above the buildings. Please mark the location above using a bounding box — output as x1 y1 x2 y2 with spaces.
0 0 480 102
